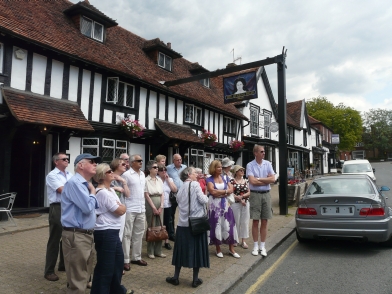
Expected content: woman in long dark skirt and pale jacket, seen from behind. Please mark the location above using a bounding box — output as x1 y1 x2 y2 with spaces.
166 167 210 288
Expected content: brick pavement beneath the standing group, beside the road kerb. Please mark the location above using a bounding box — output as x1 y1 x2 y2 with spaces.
0 181 296 294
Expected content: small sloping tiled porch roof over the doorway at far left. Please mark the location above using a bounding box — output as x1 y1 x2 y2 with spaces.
2 87 94 131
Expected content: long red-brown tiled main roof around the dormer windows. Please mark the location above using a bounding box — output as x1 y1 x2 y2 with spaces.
0 0 248 120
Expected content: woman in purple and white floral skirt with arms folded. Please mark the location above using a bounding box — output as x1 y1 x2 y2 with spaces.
206 160 240 258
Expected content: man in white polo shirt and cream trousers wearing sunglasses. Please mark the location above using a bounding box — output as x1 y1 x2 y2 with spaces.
122 154 147 271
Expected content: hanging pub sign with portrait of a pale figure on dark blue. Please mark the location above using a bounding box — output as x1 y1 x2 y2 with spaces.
223 72 257 104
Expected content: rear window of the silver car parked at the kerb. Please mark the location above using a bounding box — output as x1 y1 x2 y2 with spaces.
306 178 375 195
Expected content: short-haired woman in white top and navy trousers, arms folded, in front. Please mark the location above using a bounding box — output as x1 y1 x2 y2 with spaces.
90 163 127 293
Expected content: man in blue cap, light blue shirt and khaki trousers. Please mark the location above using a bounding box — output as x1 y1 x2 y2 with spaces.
61 153 101 293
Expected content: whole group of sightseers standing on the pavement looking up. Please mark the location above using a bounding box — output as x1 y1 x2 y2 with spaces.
44 145 275 294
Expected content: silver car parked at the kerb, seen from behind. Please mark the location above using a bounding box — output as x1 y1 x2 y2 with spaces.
295 175 392 245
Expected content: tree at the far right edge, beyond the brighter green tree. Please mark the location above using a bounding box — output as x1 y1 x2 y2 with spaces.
362 108 392 157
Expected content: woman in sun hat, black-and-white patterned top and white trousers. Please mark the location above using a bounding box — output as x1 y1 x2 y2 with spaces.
230 165 250 249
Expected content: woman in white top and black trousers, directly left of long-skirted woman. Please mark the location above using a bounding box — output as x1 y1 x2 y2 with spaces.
157 164 177 250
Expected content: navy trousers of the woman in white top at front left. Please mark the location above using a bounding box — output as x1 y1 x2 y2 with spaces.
90 230 127 294
